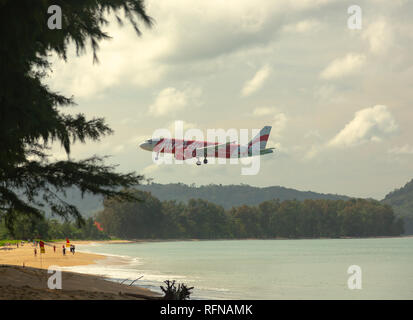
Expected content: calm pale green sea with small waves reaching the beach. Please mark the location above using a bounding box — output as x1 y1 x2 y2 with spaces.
63 237 413 300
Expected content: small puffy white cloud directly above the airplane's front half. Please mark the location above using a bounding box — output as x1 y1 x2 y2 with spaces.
149 87 201 117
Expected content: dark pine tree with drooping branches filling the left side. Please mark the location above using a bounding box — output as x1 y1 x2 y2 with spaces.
0 0 152 230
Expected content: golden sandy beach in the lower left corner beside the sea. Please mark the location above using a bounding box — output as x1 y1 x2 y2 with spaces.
0 241 159 300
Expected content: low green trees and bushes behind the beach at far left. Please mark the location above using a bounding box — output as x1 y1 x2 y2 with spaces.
0 214 109 240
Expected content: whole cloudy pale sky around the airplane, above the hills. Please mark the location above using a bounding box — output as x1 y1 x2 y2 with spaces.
47 0 413 199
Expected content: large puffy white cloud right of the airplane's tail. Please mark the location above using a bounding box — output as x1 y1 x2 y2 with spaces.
328 105 398 147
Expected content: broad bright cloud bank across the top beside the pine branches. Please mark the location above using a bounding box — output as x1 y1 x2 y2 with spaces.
48 0 334 98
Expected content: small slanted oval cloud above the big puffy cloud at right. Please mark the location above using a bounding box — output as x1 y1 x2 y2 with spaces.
320 53 366 80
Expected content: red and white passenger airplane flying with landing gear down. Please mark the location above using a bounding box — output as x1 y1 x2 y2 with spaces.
139 126 275 166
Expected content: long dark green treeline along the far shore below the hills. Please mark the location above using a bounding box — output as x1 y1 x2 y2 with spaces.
96 190 403 239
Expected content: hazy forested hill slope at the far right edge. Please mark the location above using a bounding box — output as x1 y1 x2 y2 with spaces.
383 179 413 234
